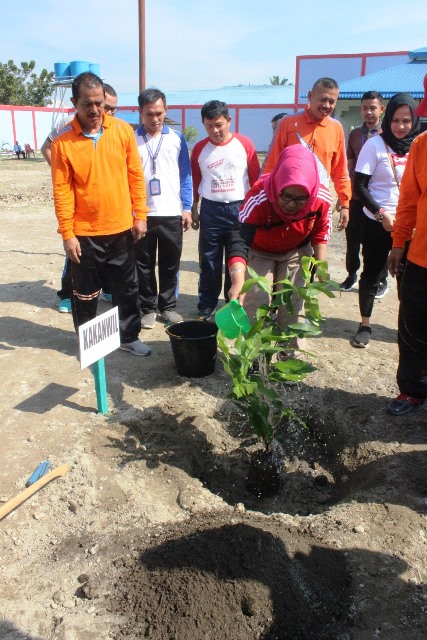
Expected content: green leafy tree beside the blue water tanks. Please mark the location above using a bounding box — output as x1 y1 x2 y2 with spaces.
0 60 54 107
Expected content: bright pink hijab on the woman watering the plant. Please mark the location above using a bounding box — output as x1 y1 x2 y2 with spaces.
263 144 320 220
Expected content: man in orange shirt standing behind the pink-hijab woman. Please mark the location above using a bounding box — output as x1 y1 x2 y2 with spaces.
262 78 351 230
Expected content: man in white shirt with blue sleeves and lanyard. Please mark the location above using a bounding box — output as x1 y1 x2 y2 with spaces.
135 89 193 329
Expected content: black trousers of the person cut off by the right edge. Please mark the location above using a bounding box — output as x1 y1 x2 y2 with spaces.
397 260 427 398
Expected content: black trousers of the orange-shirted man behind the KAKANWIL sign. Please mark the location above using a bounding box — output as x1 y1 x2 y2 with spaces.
71 230 141 343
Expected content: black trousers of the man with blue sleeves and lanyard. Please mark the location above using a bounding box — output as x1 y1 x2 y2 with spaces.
135 216 183 314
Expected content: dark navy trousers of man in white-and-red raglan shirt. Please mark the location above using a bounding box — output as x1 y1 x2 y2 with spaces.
197 198 242 309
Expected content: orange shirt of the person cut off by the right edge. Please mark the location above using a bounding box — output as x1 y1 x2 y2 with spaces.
391 132 427 268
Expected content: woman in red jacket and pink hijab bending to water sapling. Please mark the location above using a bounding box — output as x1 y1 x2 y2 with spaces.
227 144 331 347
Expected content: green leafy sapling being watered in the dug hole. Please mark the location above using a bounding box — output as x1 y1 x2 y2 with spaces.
218 257 339 449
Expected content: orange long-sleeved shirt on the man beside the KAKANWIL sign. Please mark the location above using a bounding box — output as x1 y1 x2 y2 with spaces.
52 114 148 240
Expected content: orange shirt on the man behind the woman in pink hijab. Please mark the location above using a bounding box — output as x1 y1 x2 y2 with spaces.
262 107 351 207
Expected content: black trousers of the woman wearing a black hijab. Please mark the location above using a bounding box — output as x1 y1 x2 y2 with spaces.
359 216 392 318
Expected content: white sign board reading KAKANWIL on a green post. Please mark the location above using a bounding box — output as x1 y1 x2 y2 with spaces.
79 307 120 369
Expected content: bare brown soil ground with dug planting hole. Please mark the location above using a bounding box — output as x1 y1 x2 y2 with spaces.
0 157 427 640
